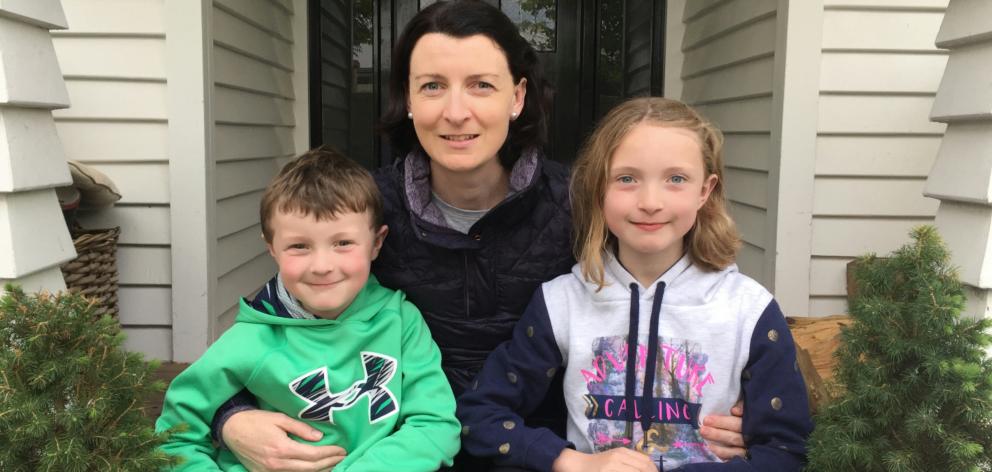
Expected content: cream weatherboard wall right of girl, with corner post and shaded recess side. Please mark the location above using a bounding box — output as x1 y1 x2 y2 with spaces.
665 0 947 315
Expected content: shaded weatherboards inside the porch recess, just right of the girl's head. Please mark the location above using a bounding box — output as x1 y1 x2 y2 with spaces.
669 0 778 285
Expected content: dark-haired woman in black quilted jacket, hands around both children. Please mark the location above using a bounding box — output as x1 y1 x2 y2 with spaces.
215 0 743 471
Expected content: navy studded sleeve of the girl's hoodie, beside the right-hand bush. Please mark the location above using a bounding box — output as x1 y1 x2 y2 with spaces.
678 300 813 472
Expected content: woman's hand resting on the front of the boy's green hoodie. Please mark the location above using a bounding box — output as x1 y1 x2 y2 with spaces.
221 410 346 472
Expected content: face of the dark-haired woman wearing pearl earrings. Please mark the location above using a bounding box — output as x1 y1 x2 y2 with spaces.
407 33 527 173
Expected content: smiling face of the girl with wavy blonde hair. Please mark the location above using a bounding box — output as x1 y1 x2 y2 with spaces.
603 123 717 275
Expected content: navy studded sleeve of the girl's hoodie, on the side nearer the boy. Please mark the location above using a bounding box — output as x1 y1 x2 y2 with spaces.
458 288 573 471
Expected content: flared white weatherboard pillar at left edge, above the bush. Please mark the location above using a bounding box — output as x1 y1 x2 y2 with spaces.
0 0 76 292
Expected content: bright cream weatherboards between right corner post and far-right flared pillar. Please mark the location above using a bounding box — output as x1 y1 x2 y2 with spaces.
809 0 947 316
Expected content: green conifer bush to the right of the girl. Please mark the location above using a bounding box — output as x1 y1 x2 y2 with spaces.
806 226 992 472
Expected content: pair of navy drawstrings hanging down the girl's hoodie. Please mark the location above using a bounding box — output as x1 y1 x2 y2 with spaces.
624 282 665 441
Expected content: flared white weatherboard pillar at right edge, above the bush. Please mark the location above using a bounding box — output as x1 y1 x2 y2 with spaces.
926 0 992 317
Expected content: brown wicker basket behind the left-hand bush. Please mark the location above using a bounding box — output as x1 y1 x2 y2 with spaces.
62 227 121 318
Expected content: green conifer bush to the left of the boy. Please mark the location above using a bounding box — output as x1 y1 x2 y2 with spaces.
0 285 175 472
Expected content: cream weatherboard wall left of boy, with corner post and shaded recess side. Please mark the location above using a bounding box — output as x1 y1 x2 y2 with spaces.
47 0 309 361
